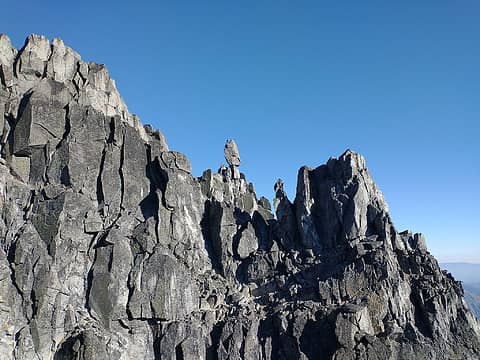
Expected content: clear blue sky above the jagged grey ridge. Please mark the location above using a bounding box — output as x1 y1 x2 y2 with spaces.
0 0 480 262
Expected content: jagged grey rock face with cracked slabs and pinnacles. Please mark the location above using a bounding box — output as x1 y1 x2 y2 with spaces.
0 35 480 360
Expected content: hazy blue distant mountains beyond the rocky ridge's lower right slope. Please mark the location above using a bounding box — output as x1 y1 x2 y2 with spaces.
440 263 480 319
